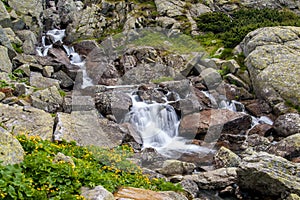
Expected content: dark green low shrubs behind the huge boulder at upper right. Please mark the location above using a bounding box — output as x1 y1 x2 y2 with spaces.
197 9 300 48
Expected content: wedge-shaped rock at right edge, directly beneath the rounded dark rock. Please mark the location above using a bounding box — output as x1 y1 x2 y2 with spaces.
268 133 300 160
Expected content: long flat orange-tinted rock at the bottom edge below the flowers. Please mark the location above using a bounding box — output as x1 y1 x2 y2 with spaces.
114 187 188 200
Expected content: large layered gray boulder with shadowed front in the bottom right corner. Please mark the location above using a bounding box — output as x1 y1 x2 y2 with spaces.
237 152 300 199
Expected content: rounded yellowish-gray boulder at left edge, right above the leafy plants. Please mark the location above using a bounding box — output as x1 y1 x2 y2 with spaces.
0 128 25 165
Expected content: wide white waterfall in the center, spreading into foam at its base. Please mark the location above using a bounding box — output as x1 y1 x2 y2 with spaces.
125 95 212 158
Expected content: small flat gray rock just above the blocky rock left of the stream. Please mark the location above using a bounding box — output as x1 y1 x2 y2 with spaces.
30 72 60 89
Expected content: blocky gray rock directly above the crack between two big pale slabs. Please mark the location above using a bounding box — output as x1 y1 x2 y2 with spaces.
30 86 63 113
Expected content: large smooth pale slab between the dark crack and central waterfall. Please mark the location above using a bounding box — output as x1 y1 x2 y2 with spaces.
54 110 125 148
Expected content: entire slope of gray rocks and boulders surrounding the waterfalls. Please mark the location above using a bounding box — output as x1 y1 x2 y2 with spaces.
0 0 300 199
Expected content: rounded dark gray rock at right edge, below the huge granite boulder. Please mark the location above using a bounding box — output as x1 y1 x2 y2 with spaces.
274 113 300 137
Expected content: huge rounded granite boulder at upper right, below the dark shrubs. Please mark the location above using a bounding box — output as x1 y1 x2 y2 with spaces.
240 27 300 109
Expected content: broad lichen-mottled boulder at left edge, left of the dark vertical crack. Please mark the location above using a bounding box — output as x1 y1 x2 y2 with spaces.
0 104 54 140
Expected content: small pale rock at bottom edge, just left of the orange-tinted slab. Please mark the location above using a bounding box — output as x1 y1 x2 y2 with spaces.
81 185 115 200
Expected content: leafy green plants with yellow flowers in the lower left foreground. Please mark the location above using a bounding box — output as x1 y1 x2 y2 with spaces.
0 135 181 200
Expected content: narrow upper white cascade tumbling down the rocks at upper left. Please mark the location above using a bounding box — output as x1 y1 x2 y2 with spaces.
36 29 94 88
